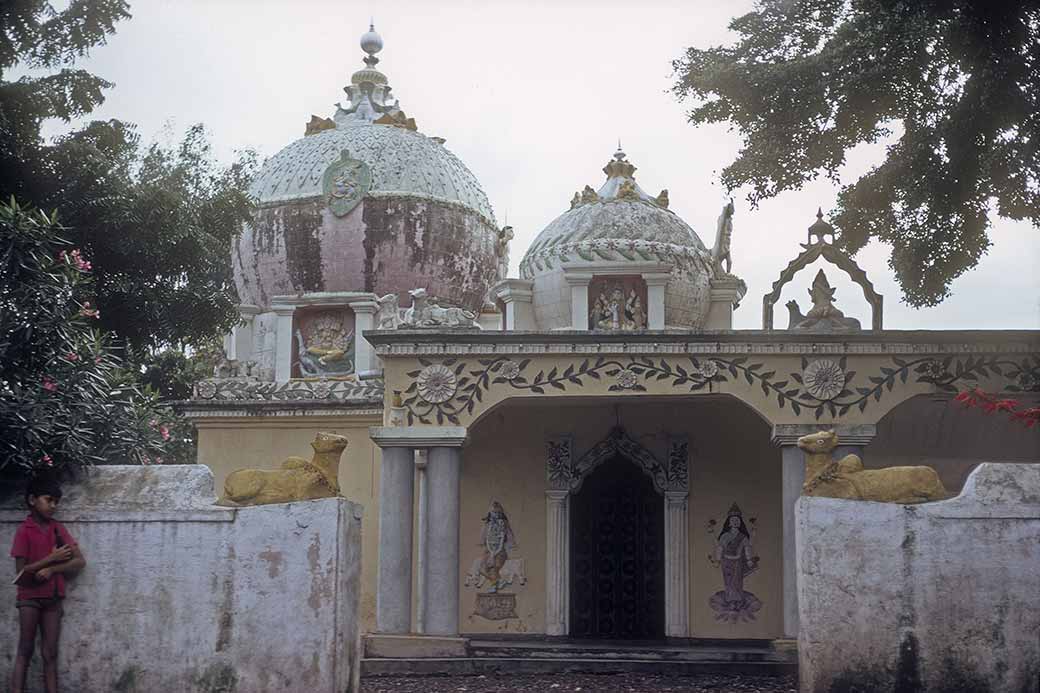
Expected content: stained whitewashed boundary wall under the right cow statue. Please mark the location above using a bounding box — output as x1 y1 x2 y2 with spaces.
797 463 1040 693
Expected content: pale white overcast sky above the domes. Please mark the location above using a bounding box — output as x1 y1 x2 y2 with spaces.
36 0 1040 329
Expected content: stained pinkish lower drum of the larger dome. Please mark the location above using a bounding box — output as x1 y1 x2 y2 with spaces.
232 196 497 310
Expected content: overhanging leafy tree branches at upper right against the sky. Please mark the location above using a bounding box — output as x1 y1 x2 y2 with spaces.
674 0 1040 306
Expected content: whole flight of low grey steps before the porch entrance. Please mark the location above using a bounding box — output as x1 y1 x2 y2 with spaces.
361 636 798 676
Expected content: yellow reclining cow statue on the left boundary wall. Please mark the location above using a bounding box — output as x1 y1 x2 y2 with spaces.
216 433 347 507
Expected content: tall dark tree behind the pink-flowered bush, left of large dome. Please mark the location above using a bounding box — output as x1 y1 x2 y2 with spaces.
0 0 256 359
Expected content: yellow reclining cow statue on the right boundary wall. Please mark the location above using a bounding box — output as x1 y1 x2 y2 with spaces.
798 431 950 504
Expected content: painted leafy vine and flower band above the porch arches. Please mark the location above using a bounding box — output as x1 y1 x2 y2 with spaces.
404 355 1040 425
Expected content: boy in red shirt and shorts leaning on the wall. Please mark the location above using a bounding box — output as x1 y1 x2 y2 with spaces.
10 479 86 693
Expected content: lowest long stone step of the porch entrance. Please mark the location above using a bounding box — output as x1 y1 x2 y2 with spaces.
361 657 798 677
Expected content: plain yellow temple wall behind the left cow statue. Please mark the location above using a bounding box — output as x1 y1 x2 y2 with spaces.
197 415 382 632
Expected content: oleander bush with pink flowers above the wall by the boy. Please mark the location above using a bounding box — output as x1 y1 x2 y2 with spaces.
0 202 172 479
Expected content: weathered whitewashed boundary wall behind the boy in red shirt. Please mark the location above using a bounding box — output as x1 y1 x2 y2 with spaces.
0 465 362 693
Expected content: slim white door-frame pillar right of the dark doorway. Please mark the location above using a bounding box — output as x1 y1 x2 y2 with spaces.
665 491 690 638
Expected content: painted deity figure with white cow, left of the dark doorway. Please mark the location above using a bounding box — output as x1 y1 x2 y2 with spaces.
465 501 527 621
